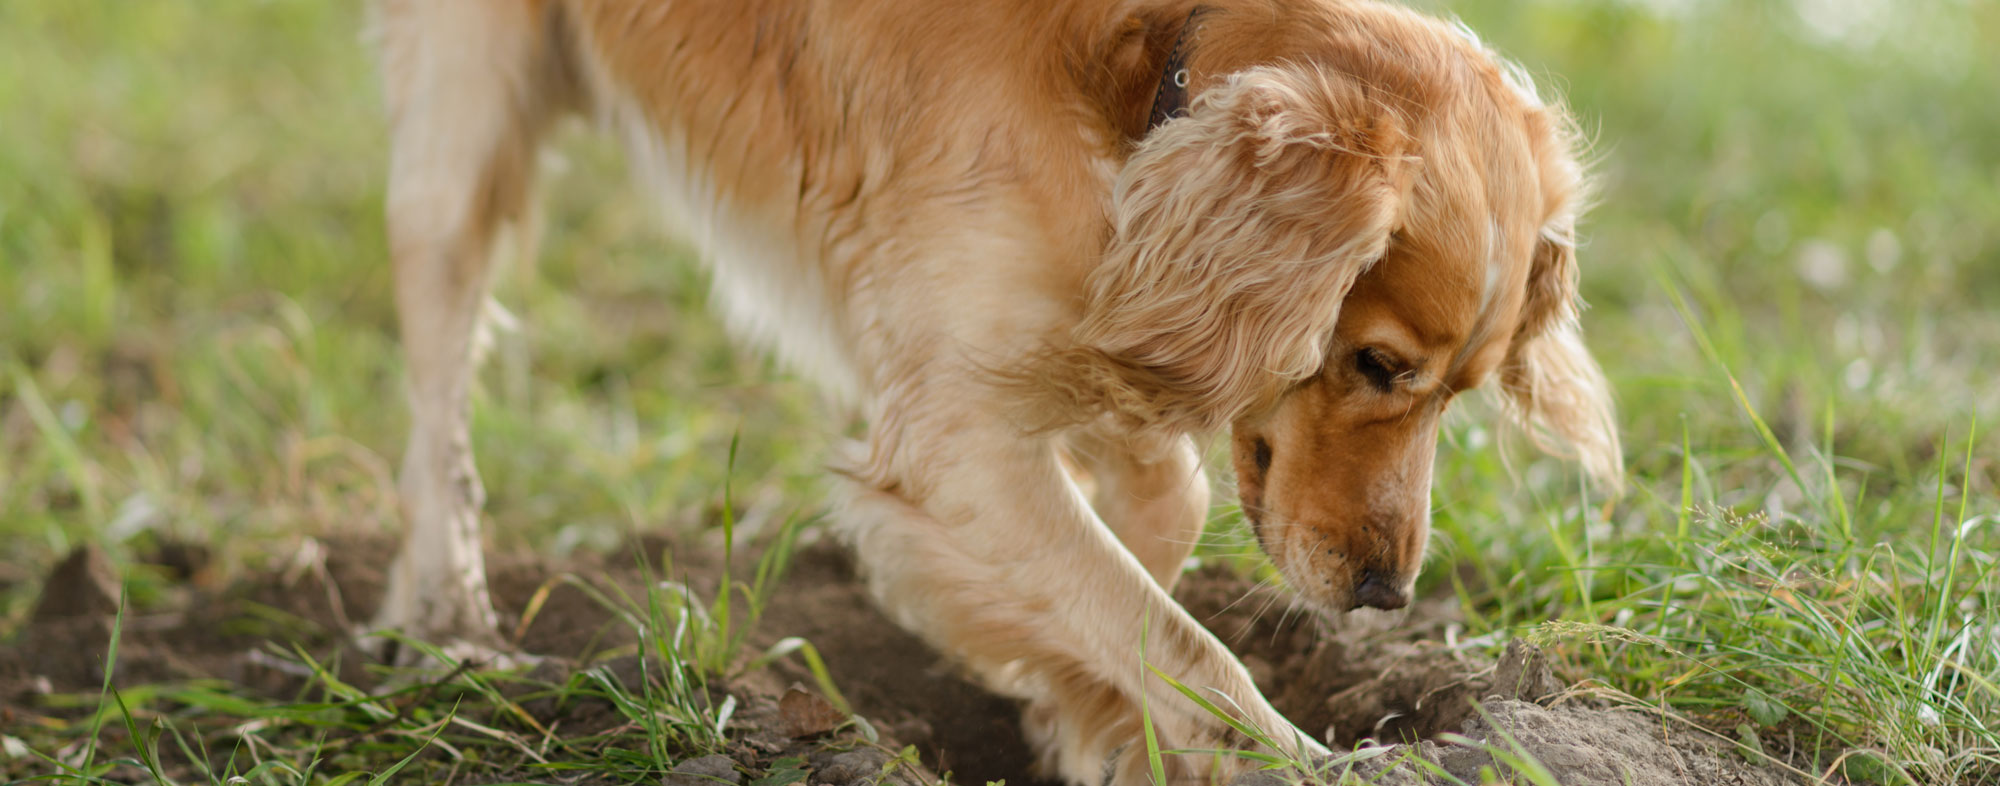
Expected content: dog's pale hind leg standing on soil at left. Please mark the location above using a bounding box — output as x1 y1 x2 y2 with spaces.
374 0 554 652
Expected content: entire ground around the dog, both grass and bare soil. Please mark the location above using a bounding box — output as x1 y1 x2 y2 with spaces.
0 0 2000 786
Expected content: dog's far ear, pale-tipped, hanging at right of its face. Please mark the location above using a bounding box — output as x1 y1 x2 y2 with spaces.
1500 216 1624 492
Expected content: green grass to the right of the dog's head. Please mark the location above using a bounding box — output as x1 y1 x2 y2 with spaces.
1408 2 2000 784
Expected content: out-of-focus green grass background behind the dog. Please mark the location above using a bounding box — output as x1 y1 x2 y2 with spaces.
0 0 2000 644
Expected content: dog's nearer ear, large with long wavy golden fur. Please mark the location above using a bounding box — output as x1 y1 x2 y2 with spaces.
1040 68 1412 432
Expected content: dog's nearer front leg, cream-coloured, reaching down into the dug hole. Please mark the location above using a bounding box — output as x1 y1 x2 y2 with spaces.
846 412 1324 786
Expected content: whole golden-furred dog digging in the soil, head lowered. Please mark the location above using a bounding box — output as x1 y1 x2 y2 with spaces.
376 0 1620 784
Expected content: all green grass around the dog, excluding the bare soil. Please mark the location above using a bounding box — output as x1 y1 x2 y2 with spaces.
0 0 2000 784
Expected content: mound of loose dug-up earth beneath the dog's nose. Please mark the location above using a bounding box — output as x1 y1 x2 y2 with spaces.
1176 574 1792 786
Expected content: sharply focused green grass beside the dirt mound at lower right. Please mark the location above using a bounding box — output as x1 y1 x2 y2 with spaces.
1534 426 2000 784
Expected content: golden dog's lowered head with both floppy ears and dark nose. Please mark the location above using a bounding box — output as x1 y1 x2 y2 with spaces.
1062 4 1620 610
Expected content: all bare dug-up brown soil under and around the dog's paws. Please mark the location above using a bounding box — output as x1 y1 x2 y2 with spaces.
0 538 1808 786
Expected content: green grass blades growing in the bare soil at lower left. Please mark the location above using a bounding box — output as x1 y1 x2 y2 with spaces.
10 518 820 786
